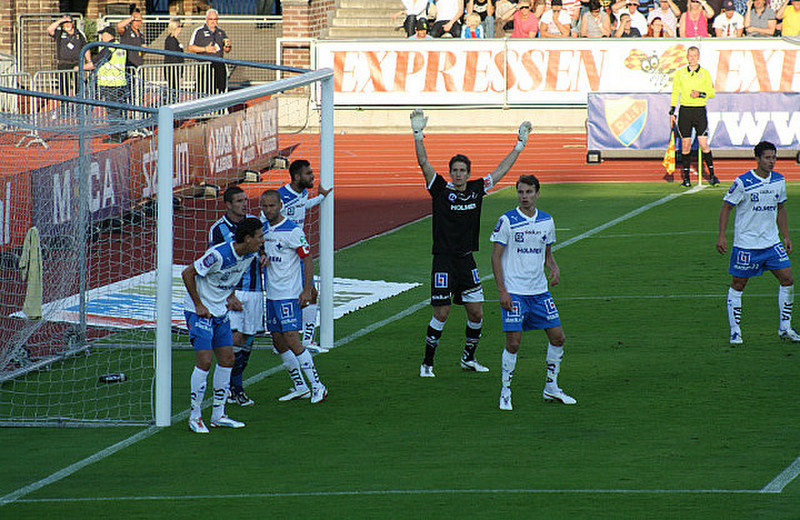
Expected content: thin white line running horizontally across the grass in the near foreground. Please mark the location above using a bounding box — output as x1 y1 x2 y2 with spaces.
18 489 764 504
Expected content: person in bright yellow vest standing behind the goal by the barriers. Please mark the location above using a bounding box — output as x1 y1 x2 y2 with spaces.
95 25 128 143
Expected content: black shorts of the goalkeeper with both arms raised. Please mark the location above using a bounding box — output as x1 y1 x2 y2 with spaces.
431 253 483 307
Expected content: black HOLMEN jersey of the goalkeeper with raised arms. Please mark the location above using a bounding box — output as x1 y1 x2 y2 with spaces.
428 175 492 256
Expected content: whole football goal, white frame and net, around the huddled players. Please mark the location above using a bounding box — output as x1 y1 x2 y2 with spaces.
0 50 333 426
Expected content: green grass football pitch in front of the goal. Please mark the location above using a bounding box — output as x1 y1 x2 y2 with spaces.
0 182 800 520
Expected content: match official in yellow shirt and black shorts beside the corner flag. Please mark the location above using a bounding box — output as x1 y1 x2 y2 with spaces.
669 46 719 188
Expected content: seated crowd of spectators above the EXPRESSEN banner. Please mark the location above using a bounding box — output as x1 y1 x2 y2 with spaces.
393 0 800 39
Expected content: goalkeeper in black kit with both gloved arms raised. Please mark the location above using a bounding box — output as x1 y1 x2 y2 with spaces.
411 110 531 377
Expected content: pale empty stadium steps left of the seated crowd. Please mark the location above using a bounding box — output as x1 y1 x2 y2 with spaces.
327 0 405 39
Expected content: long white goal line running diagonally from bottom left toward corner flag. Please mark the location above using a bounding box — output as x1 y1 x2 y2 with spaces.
0 186 702 507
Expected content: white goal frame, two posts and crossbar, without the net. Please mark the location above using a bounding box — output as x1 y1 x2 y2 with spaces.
154 69 334 426
